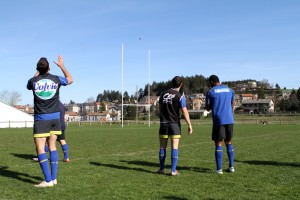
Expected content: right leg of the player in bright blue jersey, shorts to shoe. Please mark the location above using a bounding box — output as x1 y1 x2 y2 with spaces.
225 124 234 172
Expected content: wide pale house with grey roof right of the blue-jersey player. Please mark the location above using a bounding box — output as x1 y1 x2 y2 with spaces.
242 99 274 114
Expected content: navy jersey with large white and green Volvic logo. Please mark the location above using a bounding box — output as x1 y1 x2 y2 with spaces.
27 73 68 120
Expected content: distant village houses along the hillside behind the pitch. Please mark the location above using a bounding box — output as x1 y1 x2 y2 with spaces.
15 81 292 122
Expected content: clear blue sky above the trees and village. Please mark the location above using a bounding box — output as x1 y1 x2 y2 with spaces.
0 0 300 104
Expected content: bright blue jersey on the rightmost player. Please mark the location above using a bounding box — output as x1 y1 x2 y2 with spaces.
205 85 234 126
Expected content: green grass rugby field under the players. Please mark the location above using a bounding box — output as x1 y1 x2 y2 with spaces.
0 124 300 200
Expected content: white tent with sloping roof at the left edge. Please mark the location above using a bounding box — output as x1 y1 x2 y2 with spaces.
0 102 33 128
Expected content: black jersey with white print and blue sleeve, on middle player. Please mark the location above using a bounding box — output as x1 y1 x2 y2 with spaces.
159 89 186 123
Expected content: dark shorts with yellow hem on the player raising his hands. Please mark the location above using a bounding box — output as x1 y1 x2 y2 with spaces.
33 119 61 137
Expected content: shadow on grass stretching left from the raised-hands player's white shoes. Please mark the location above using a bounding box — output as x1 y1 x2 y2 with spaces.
0 167 41 184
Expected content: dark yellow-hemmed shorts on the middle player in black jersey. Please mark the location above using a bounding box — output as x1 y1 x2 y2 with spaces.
159 122 181 138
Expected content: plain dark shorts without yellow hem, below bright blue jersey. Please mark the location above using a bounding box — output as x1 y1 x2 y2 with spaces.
212 124 233 141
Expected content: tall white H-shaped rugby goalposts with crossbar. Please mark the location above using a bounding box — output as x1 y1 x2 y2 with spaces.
122 44 151 128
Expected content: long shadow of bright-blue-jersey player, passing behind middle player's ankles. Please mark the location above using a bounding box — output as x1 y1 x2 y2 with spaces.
120 160 211 173
